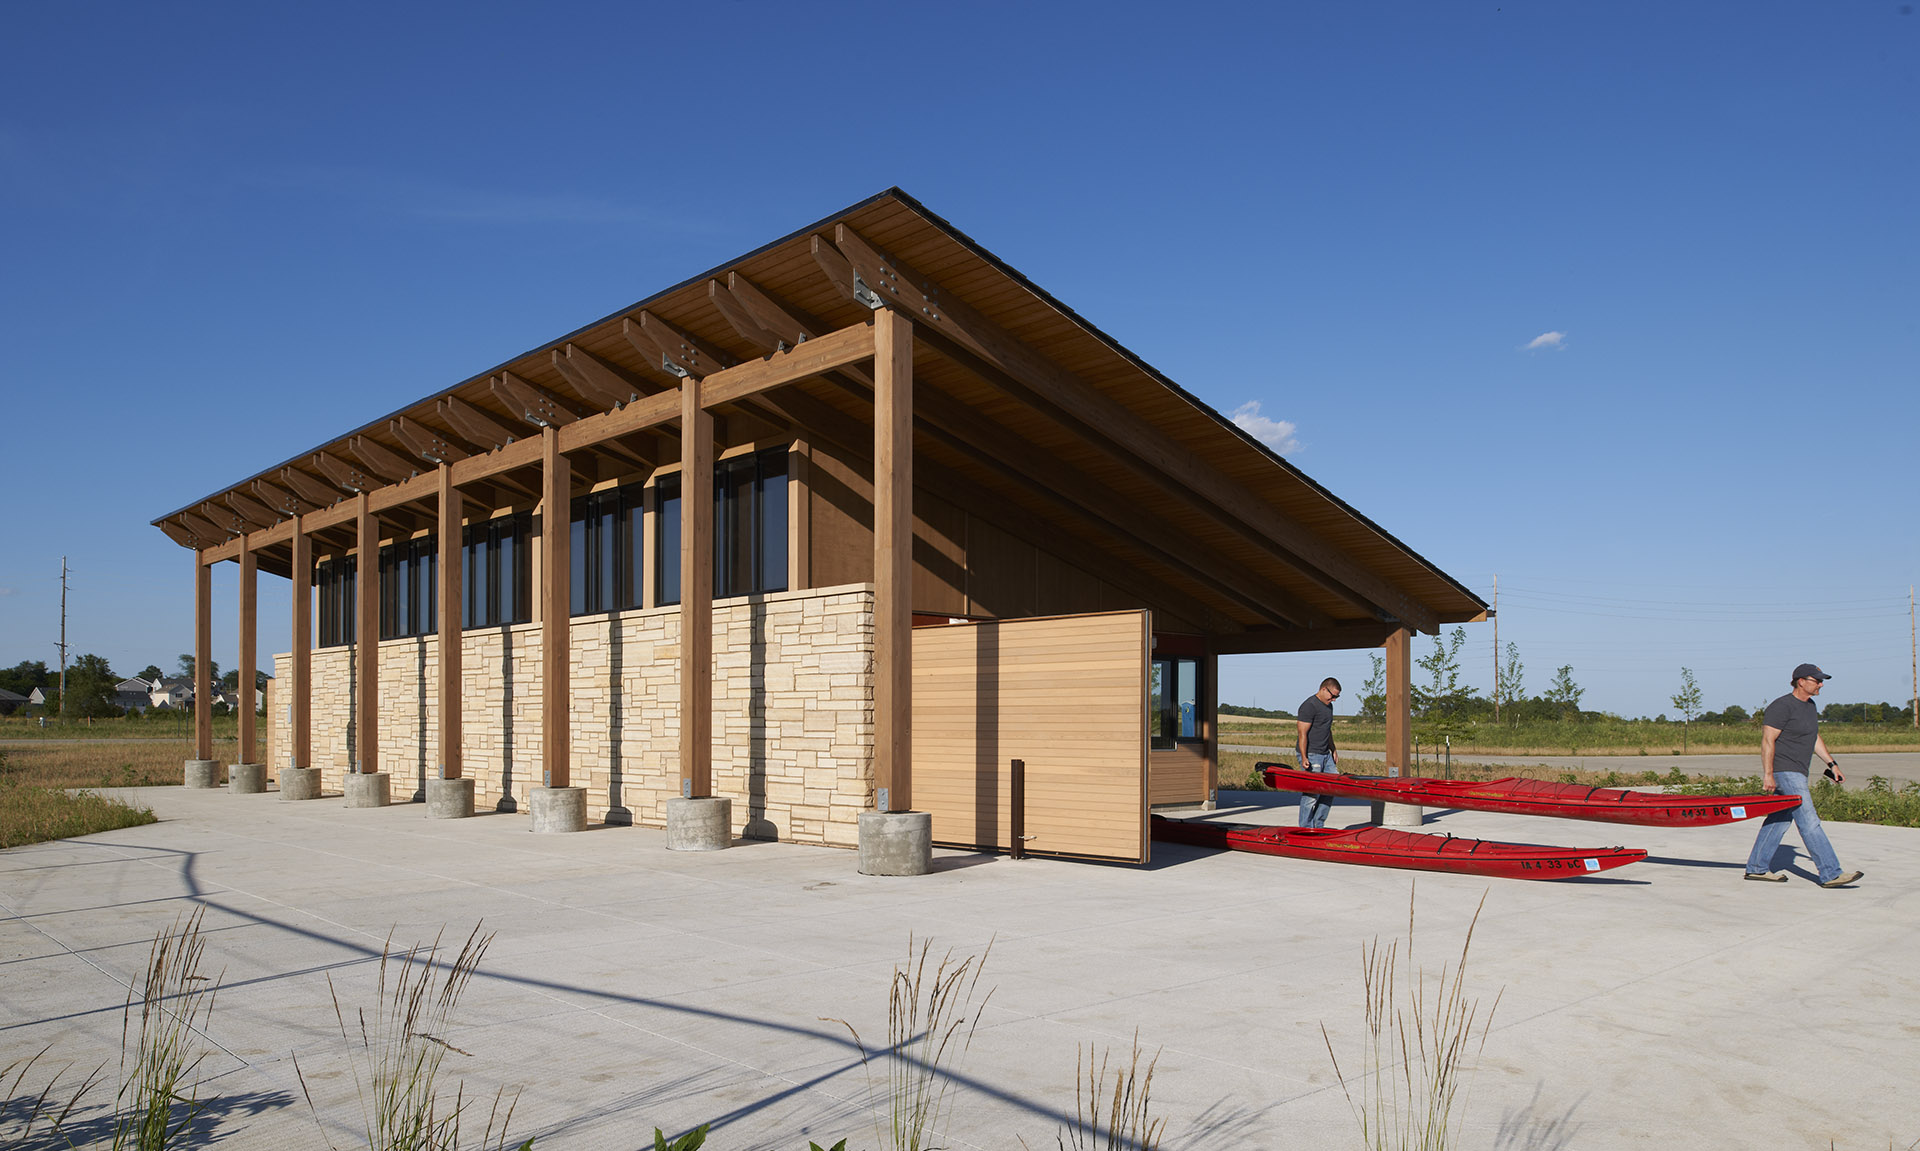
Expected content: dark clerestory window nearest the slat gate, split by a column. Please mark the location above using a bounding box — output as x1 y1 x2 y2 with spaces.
655 448 787 603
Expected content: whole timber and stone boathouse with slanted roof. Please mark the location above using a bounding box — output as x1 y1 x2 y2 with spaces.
154 188 1486 870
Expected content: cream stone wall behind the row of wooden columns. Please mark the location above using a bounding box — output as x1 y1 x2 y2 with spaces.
269 584 874 847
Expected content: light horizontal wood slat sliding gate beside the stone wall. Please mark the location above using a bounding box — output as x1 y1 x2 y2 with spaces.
914 611 1154 863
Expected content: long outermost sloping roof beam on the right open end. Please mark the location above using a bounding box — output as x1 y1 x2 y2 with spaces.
814 225 1438 632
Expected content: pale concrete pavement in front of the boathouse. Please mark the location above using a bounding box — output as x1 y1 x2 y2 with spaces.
0 788 1920 1151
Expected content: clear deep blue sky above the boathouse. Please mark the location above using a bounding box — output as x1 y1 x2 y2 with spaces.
0 0 1920 715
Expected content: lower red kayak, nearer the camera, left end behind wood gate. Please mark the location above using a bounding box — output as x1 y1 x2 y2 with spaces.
1154 815 1647 880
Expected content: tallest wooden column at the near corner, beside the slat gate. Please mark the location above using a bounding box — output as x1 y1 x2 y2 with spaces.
874 309 914 811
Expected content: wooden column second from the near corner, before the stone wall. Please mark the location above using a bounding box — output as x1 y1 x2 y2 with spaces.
680 379 714 799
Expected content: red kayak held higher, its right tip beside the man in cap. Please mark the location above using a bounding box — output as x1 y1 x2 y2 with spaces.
1254 763 1799 828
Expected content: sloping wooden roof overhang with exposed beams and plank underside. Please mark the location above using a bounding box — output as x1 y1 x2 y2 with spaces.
154 188 1486 651
